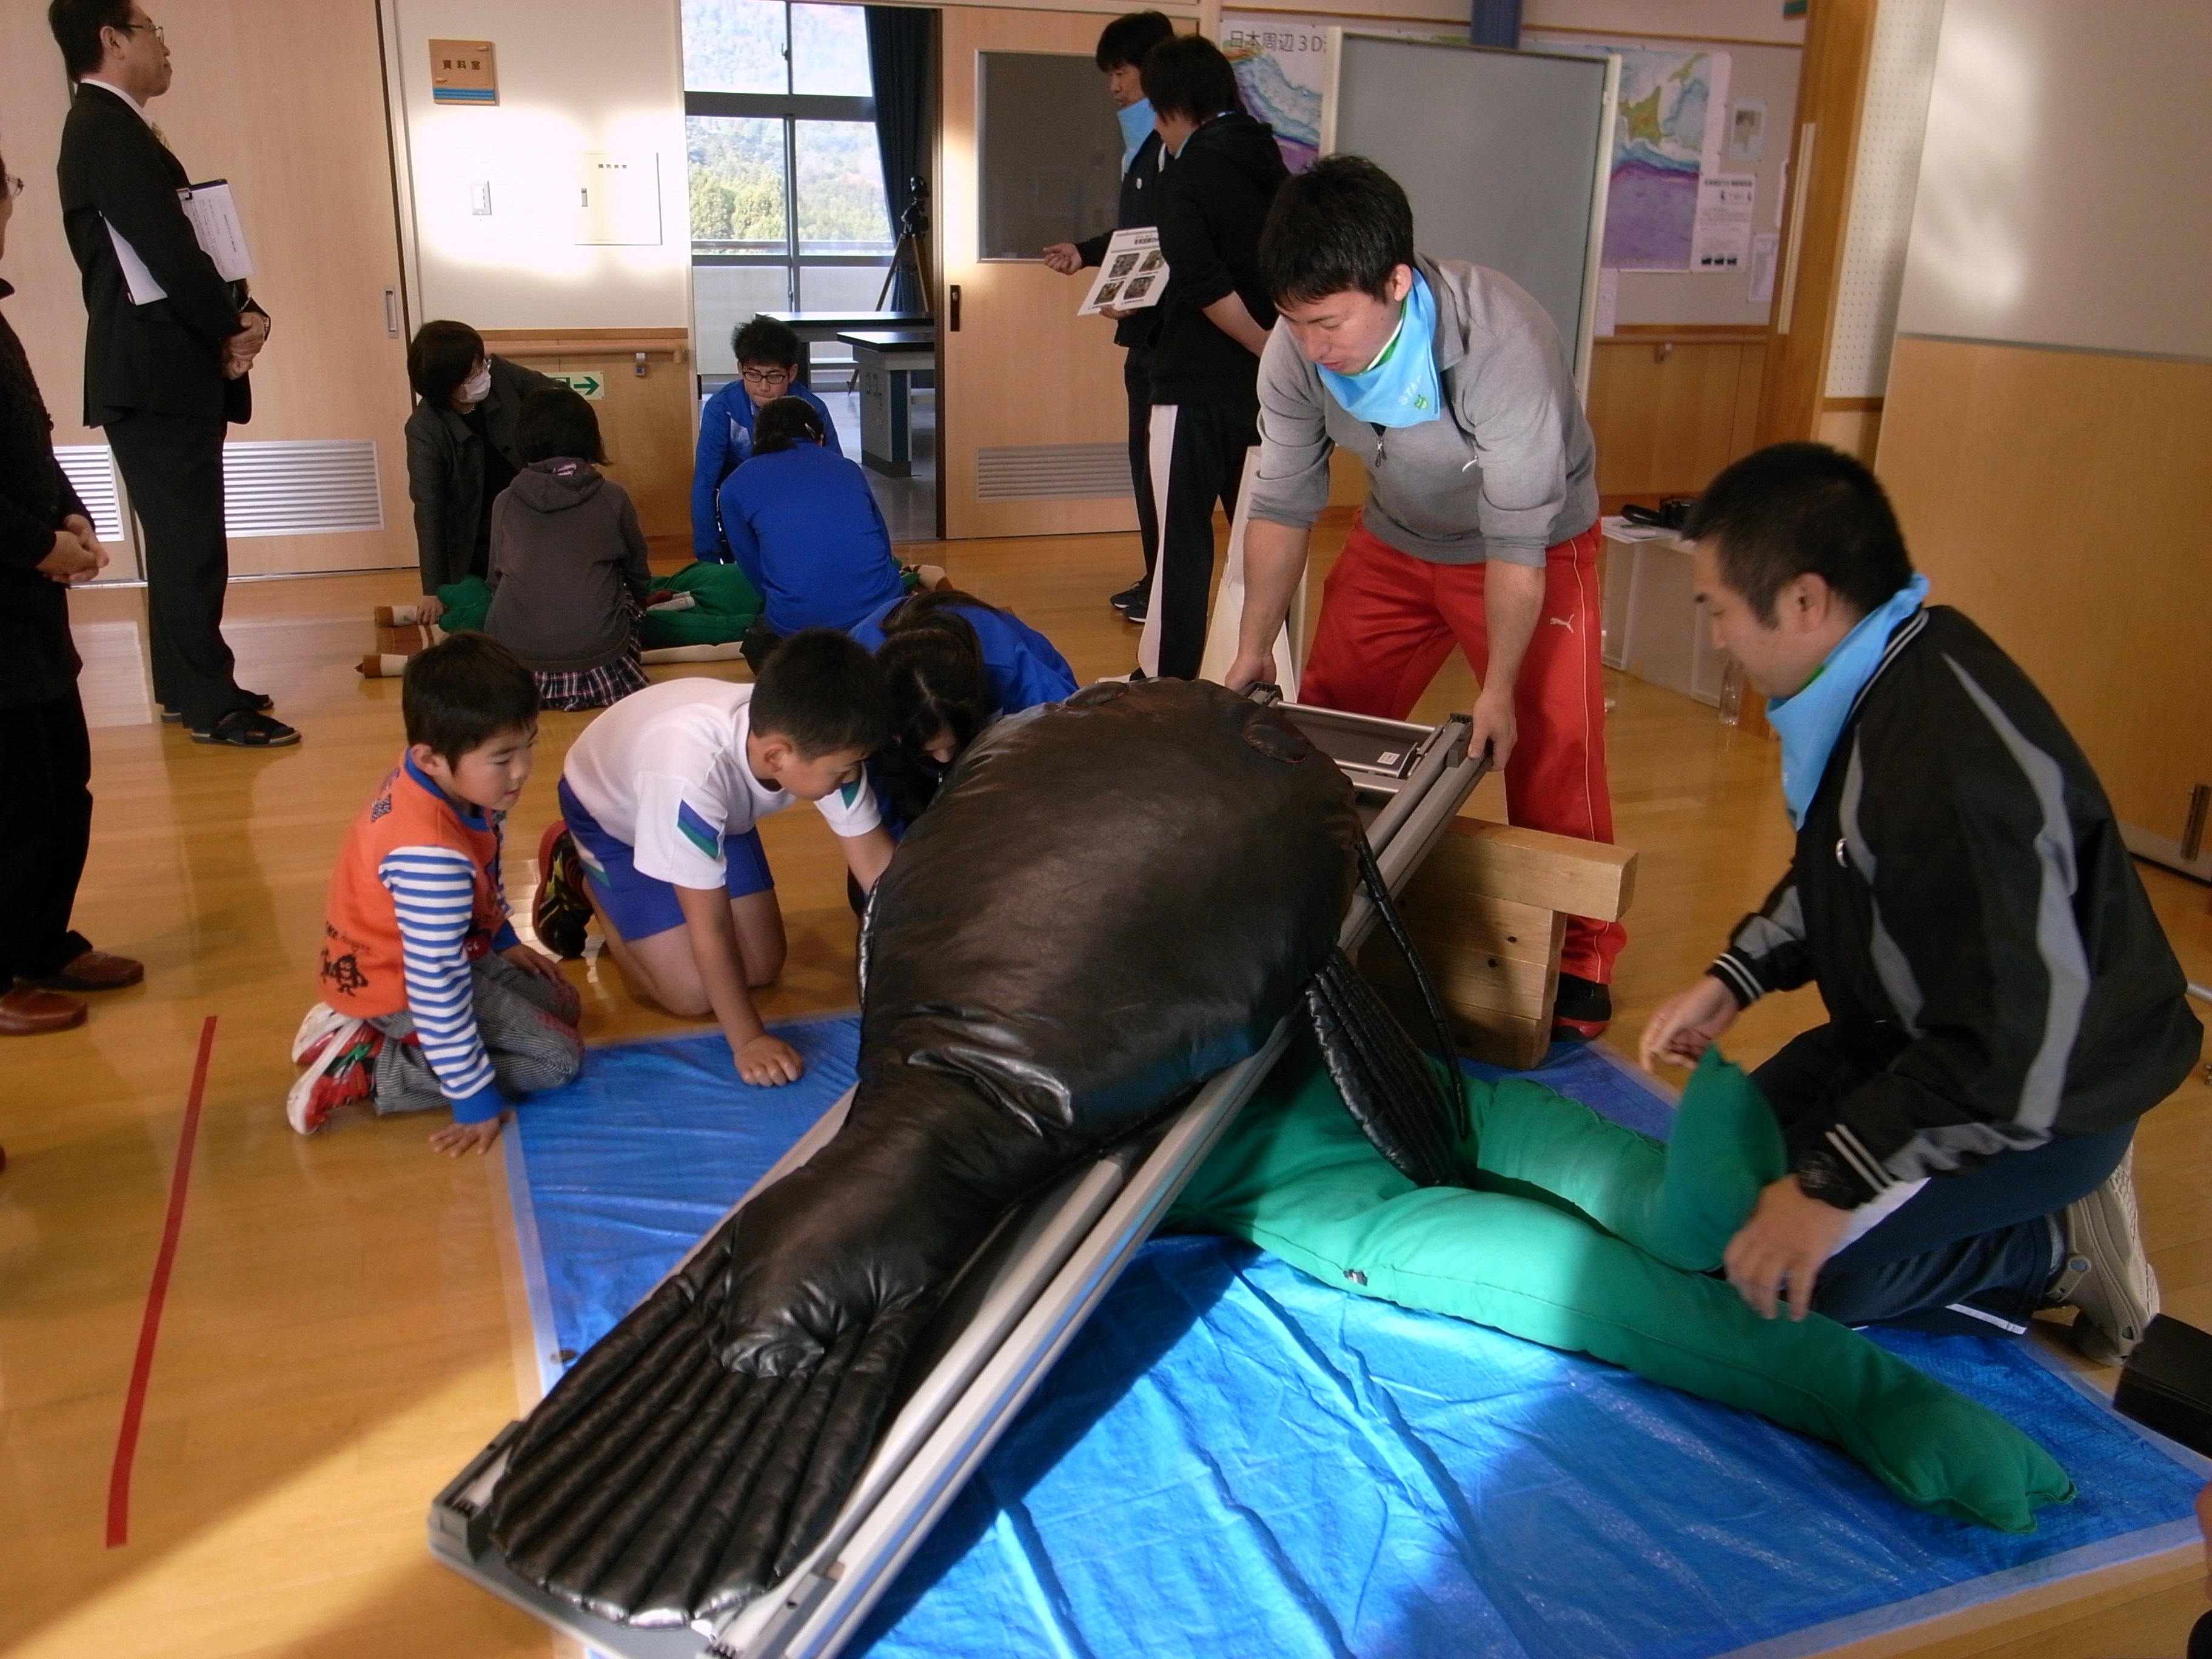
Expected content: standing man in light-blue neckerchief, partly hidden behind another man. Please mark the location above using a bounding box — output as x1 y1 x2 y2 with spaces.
1044 11 1175 622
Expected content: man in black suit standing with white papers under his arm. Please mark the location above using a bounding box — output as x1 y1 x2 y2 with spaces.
47 0 298 748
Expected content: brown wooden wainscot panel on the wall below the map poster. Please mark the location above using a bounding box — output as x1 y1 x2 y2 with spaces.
1590 327 1768 511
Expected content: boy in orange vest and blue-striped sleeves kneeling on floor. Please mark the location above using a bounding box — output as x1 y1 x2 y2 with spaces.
286 632 584 1157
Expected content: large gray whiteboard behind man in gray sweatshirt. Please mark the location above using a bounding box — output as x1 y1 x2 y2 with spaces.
1321 28 1619 389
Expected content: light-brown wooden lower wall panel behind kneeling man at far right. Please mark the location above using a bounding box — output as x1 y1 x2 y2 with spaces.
1878 336 2212 858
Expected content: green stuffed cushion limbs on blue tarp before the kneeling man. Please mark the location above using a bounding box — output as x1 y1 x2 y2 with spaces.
1175 1055 2073 1533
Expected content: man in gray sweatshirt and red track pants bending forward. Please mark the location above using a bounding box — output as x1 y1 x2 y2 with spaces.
1228 155 1628 1037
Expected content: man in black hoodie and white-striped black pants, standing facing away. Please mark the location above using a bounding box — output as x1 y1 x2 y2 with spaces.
1139 35 1290 679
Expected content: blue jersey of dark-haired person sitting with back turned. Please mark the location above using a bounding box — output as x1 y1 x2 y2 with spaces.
719 444 900 635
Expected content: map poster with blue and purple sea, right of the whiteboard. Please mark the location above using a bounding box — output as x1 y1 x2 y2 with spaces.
1544 42 1730 270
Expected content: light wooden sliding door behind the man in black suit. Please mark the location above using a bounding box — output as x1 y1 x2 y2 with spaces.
0 0 416 575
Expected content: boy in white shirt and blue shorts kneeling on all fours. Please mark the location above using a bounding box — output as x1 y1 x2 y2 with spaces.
533 628 891 1086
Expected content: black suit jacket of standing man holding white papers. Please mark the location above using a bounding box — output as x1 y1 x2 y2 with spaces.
58 86 259 427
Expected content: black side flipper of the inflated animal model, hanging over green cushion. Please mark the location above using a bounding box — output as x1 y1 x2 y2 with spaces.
1305 951 1467 1185
